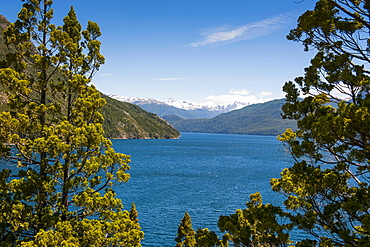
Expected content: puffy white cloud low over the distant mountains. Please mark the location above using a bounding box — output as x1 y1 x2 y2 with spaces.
203 89 281 105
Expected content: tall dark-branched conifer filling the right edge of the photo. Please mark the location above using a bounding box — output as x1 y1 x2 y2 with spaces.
271 0 370 246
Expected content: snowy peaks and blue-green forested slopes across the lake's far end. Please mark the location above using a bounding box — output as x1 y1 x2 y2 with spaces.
108 94 296 135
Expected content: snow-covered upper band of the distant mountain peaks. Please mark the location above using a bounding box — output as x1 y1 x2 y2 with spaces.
106 93 249 114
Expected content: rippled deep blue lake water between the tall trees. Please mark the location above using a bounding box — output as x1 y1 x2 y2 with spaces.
113 133 292 247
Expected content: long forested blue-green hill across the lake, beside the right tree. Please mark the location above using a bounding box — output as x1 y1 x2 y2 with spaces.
163 99 296 135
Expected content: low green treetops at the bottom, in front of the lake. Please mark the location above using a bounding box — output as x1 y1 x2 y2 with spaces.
175 193 292 247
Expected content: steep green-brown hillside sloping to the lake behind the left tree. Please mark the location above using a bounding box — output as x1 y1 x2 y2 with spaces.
0 15 180 139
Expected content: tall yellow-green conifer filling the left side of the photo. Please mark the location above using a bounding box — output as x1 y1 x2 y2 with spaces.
0 0 143 246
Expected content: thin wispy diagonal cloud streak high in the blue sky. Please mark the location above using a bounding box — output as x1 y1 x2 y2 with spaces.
189 14 292 47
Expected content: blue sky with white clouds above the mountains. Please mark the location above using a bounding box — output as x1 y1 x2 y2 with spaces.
0 0 315 105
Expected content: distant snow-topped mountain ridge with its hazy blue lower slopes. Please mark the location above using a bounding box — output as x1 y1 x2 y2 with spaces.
106 93 248 119
